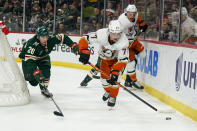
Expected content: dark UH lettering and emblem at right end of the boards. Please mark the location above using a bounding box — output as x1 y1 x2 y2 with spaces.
175 53 197 91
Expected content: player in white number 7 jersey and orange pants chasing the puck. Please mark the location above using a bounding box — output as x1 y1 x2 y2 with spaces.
79 20 129 107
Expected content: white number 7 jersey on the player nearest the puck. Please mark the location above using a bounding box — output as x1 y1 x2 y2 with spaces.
88 28 129 61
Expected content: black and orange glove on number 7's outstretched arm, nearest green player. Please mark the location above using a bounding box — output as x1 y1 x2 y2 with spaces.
79 49 90 64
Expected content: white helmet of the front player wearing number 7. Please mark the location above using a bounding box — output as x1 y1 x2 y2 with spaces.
108 20 122 33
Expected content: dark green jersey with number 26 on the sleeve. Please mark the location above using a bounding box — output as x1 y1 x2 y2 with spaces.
19 34 78 61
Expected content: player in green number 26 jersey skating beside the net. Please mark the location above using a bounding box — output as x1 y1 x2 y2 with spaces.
19 27 90 97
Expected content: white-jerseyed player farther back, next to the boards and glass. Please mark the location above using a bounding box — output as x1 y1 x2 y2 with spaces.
118 5 148 89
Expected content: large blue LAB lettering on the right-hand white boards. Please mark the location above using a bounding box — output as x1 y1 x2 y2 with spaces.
136 49 159 77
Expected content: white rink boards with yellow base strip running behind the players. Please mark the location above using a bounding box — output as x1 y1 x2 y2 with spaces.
8 33 197 121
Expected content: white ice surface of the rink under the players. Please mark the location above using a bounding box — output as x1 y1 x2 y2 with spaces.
0 65 197 131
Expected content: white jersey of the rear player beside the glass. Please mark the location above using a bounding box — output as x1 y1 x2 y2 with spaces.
118 13 138 40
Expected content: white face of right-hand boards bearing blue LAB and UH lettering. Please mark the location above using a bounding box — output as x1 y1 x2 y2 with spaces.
136 42 197 109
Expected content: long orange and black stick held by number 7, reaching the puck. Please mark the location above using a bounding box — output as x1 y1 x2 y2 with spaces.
88 62 175 113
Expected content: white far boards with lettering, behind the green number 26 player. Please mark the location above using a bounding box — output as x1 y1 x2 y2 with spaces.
7 33 98 63
